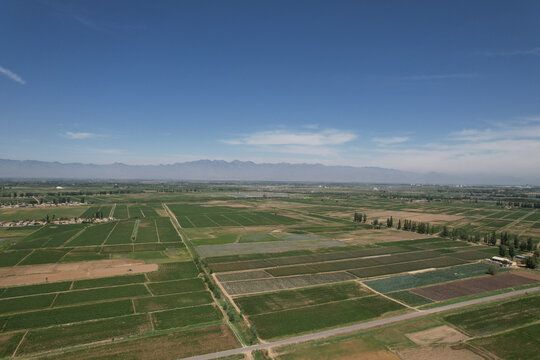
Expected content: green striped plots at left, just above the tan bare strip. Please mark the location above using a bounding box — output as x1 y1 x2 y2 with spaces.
0 217 184 266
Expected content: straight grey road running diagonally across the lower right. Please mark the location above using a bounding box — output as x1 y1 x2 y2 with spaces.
181 286 540 360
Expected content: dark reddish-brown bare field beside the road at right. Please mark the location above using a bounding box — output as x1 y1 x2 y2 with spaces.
411 272 538 301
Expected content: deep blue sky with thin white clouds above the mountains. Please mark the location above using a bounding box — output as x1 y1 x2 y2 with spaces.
0 0 540 178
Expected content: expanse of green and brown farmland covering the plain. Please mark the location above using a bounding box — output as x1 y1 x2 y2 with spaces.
0 185 540 359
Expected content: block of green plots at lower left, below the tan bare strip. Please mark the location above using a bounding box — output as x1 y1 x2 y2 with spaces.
0 262 235 356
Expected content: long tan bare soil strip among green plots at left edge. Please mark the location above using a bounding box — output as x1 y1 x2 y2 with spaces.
0 259 158 287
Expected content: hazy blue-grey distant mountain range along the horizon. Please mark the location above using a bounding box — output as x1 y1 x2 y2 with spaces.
0 159 540 185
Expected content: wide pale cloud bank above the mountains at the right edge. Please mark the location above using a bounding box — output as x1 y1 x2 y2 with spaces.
363 117 540 179
